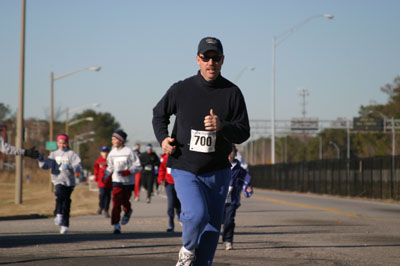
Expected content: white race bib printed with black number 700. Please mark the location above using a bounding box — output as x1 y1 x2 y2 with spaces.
189 129 217 153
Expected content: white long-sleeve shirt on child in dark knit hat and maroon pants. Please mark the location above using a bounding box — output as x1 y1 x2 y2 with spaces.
104 146 141 185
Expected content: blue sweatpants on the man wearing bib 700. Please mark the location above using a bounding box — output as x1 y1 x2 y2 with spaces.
171 168 231 266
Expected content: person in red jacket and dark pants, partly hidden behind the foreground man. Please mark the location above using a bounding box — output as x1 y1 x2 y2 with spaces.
157 153 181 232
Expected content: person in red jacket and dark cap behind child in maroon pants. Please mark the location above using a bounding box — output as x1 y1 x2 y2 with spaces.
93 146 112 218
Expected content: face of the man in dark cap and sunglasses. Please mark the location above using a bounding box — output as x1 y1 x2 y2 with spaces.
196 51 224 81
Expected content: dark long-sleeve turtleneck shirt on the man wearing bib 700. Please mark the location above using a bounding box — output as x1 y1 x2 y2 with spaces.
153 71 250 174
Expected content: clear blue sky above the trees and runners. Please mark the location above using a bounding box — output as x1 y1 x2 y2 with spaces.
0 0 400 144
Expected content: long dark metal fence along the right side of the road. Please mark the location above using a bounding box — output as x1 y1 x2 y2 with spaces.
249 156 400 200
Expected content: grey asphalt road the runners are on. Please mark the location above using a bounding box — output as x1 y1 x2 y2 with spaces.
0 190 400 266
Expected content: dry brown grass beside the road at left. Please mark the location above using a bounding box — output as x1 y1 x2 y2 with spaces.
0 168 98 217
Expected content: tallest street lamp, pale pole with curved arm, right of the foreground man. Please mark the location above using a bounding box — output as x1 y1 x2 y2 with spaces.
271 14 333 164
